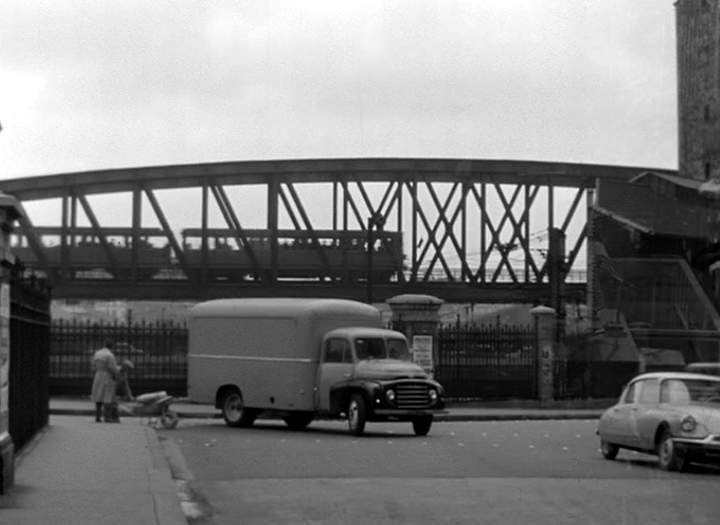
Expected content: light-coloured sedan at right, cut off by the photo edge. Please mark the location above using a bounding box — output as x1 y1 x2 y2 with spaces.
597 372 720 470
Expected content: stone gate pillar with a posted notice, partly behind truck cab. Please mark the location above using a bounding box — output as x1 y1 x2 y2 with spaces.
387 294 443 375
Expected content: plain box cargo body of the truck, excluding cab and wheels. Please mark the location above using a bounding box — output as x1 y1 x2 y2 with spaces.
188 298 382 411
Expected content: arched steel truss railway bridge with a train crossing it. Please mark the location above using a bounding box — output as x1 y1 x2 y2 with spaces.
0 158 673 303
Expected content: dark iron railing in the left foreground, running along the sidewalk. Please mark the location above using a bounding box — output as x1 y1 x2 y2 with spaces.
8 278 50 450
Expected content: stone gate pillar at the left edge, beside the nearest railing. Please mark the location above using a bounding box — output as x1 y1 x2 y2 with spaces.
0 192 21 493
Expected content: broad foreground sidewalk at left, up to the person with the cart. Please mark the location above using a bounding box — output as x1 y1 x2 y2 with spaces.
0 415 187 525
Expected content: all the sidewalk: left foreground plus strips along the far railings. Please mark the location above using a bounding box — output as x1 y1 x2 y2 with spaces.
0 398 612 525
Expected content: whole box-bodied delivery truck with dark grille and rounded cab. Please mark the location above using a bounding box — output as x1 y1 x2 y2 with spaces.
188 298 443 435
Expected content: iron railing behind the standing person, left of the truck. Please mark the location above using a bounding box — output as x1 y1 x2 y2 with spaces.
50 320 188 396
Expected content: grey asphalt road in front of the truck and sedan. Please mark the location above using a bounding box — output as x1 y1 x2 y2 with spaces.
161 420 720 525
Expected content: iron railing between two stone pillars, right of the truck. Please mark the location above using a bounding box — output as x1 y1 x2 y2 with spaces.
435 324 538 401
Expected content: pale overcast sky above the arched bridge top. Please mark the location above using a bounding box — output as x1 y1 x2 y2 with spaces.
0 0 677 178
